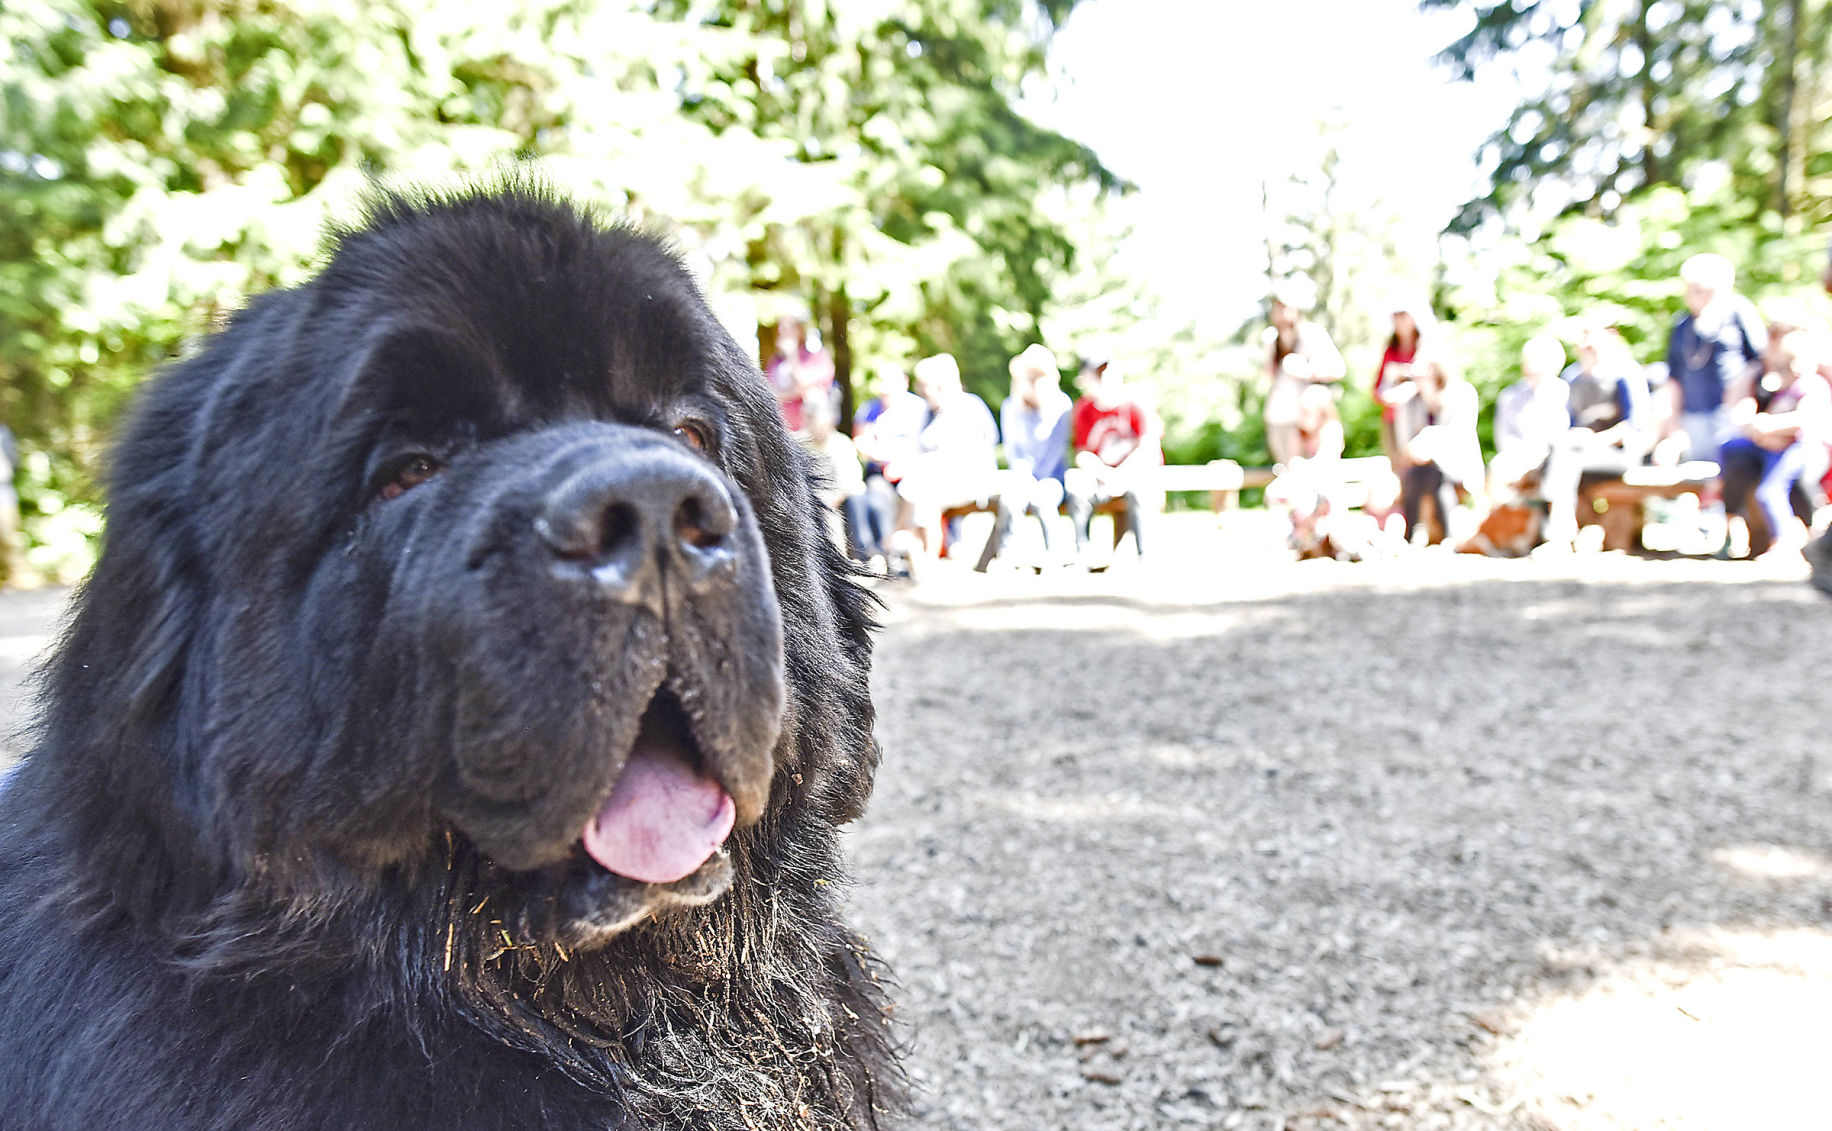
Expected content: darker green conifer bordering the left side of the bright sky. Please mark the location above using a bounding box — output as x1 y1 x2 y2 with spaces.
663 0 1123 414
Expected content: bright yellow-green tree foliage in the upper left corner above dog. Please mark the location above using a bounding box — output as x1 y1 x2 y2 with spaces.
0 0 696 554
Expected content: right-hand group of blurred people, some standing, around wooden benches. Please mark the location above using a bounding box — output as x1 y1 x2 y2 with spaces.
1266 253 1832 568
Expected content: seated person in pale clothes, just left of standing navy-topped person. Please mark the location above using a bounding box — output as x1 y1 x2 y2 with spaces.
1539 323 1654 550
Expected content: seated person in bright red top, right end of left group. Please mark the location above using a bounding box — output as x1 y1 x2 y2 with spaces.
1064 356 1163 565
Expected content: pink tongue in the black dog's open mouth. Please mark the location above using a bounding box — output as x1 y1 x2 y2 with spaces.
584 741 738 884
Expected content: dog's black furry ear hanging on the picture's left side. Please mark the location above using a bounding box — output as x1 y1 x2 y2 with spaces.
26 308 266 918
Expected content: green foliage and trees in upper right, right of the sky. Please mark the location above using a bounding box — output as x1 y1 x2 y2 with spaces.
1363 0 1832 472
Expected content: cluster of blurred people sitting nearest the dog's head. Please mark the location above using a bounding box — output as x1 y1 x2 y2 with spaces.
764 319 1163 576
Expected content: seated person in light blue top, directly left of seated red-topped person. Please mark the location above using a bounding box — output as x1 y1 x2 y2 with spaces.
973 345 1074 572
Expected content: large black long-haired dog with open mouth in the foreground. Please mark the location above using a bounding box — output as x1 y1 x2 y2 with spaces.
0 185 898 1131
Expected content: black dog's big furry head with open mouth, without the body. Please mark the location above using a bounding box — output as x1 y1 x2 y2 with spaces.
48 189 872 948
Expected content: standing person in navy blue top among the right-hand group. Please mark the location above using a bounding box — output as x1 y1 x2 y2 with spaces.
1660 253 1768 462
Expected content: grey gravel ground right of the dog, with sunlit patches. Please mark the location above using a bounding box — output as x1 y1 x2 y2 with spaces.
854 579 1832 1129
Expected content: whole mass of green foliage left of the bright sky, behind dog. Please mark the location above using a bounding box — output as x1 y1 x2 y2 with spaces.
0 0 1121 574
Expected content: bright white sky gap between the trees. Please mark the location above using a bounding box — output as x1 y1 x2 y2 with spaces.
1026 0 1517 334
